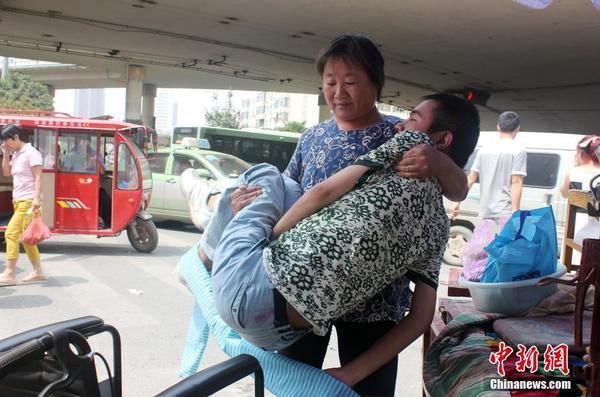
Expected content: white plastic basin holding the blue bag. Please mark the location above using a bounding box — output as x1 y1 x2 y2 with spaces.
458 264 567 316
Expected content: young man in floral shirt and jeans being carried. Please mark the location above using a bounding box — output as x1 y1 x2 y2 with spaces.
201 94 479 380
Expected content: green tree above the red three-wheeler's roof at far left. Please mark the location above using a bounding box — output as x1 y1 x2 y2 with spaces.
0 72 53 111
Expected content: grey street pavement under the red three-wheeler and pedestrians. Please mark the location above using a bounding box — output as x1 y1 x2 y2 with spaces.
0 222 432 397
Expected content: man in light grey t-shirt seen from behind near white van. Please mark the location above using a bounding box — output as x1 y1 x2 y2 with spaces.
450 112 527 220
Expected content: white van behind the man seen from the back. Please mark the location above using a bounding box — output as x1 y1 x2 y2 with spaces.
444 131 583 266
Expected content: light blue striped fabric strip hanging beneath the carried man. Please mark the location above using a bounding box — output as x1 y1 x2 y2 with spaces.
178 241 358 397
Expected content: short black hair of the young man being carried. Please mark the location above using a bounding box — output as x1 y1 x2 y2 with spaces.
422 94 479 168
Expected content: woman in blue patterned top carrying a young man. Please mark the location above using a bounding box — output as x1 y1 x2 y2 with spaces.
223 35 467 396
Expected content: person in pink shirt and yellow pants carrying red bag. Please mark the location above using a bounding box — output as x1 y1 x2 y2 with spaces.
0 124 46 286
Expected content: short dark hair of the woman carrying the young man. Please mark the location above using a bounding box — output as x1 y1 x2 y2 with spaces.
317 34 385 100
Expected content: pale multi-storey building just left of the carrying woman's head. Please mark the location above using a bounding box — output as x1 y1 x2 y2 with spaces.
238 92 319 129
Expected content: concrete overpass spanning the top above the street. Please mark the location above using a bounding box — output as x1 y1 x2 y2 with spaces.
0 0 600 133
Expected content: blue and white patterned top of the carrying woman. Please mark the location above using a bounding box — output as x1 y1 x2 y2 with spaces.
285 115 411 323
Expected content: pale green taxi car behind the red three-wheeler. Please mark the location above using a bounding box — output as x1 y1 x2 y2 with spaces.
147 146 250 223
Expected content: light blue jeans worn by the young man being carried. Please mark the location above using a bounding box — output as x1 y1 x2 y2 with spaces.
201 164 308 350
